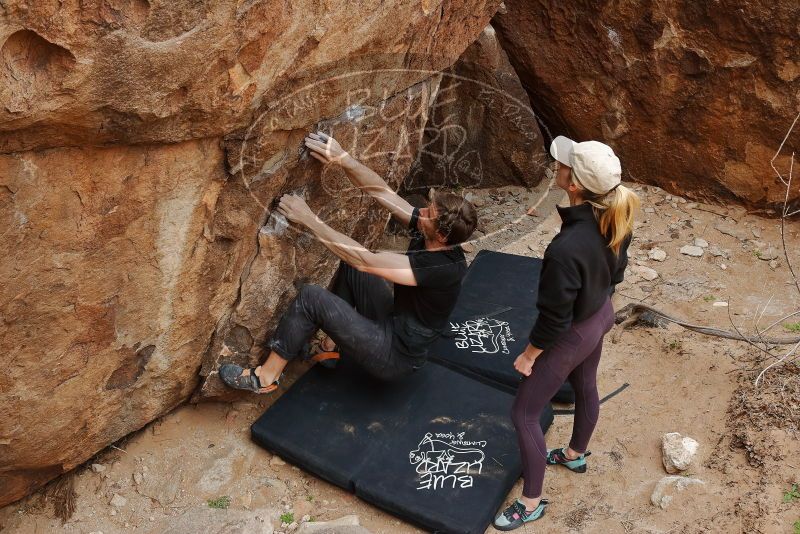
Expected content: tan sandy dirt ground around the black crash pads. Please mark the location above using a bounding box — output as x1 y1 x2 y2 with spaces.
0 184 800 534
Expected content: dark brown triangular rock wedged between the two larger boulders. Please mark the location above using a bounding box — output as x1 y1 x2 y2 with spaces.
404 26 548 192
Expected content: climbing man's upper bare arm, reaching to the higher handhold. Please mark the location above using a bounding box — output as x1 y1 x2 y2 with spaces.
305 132 414 226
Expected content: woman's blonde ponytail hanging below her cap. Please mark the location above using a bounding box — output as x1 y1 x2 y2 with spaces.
577 180 641 255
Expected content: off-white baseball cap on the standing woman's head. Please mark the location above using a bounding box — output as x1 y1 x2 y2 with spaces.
550 135 622 195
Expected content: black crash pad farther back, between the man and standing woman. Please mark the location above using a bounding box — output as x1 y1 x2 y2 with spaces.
430 250 575 403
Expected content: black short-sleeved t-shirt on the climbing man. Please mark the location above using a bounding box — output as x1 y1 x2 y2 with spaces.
394 230 467 358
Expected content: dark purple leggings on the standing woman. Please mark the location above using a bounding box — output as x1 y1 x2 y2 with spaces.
511 300 614 499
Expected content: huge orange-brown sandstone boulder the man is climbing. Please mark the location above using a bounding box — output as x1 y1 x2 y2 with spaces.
0 0 497 505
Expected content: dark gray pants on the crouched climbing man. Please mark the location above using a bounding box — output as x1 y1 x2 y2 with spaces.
268 262 414 380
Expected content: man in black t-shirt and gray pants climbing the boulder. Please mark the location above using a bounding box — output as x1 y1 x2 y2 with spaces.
219 132 477 393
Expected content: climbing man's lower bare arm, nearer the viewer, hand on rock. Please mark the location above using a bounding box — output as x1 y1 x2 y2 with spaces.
278 195 417 286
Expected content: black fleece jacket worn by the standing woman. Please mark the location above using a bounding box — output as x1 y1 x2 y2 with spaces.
528 203 632 350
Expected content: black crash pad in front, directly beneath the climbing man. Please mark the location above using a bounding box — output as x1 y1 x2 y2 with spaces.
251 360 553 534
